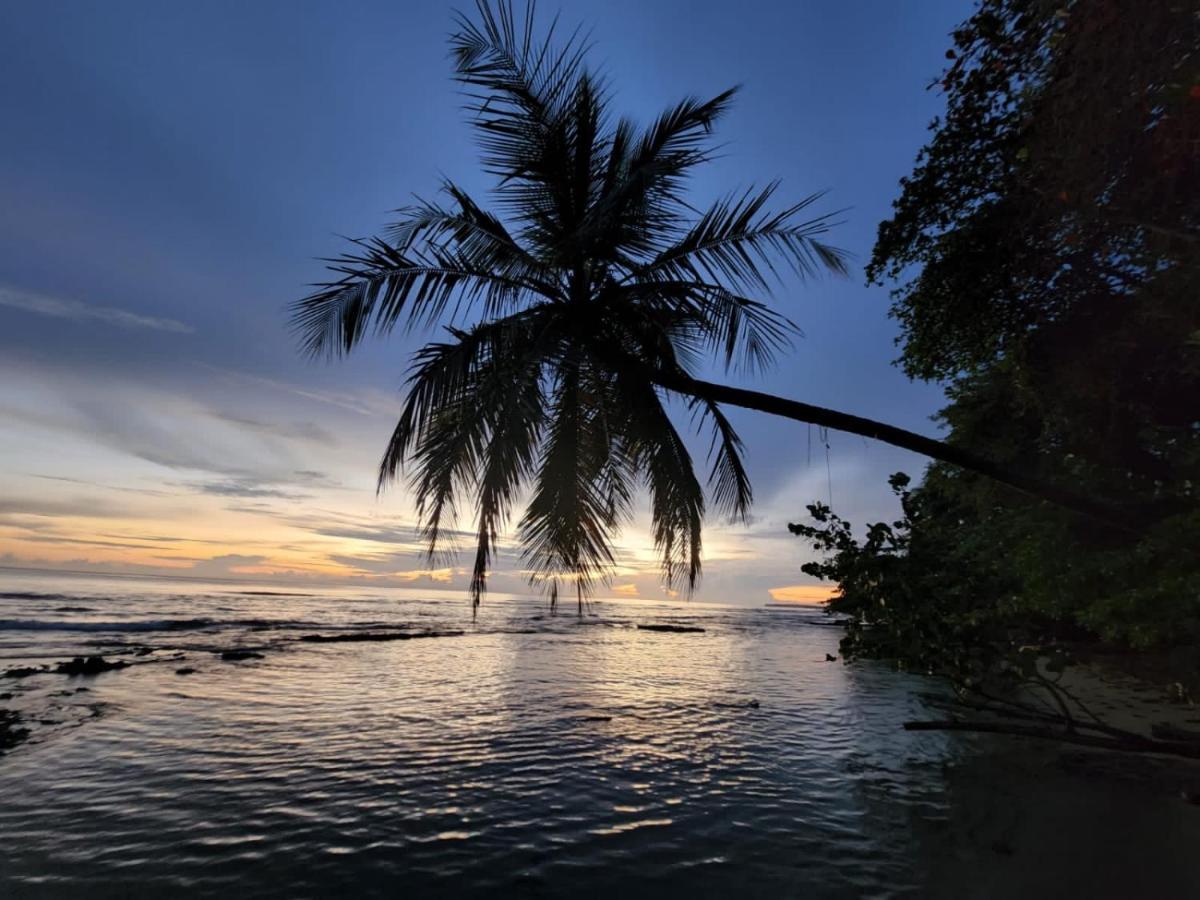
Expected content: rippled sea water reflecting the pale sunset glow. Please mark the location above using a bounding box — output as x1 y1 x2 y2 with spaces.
0 574 1200 898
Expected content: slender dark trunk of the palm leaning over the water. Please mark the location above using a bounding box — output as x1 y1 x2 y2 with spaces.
650 372 1142 530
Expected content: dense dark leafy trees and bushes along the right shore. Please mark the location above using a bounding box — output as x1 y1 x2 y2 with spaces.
792 0 1200 683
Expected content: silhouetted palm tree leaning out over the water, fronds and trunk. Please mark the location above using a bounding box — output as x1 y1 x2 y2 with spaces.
294 0 1123 606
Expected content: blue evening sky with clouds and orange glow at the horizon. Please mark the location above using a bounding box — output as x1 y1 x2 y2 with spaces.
0 0 970 606
